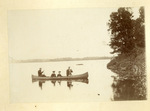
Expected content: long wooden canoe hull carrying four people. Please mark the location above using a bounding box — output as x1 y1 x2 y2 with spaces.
32 72 88 80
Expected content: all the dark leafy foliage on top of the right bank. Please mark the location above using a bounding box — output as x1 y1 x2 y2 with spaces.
108 7 145 53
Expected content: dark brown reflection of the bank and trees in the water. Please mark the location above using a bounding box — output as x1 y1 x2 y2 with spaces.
112 77 145 101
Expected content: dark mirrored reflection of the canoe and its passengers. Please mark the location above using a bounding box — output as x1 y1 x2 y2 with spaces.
32 79 89 90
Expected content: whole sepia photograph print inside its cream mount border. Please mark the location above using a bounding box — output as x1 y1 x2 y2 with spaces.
7 6 147 103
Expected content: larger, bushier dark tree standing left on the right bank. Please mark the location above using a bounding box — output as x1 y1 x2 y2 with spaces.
108 7 135 53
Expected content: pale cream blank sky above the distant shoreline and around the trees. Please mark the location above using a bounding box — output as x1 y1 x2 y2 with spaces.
8 8 138 59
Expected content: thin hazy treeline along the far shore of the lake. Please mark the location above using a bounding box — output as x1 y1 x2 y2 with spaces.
10 57 112 63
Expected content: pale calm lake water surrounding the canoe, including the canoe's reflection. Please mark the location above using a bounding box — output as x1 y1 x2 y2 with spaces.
10 60 114 102
